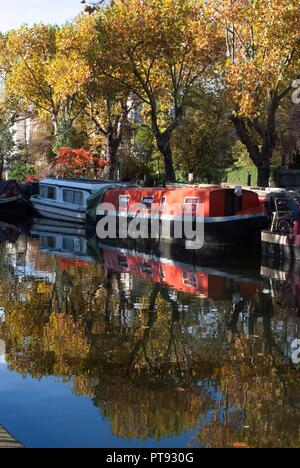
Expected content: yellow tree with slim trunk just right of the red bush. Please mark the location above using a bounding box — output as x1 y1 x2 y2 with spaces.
52 15 134 178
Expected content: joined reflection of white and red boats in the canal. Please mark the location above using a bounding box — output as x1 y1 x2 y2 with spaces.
31 219 261 299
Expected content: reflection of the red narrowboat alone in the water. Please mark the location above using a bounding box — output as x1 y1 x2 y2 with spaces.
98 244 261 299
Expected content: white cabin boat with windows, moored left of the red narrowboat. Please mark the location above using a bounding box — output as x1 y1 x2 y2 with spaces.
30 178 134 224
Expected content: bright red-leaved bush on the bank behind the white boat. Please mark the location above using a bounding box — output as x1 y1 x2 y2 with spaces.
51 148 107 178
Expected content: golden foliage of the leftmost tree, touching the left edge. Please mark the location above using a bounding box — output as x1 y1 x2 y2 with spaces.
0 24 81 151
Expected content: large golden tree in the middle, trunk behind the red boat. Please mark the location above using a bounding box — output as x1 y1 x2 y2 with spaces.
92 0 222 180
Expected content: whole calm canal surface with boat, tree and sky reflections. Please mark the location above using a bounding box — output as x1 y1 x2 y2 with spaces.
0 223 300 448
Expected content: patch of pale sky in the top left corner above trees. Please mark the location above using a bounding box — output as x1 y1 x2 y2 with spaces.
0 0 82 32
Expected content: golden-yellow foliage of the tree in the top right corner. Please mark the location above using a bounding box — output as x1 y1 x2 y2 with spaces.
211 0 300 116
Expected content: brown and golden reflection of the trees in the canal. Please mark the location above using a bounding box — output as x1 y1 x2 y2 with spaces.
0 239 300 447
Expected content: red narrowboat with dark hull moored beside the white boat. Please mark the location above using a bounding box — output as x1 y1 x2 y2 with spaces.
92 185 267 249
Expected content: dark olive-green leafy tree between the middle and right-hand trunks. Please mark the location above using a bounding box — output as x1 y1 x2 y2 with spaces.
172 86 235 183
